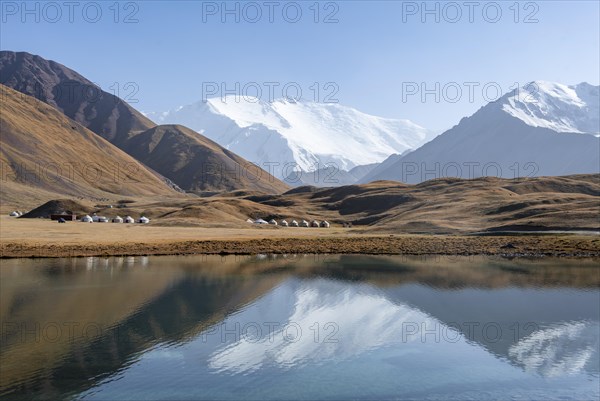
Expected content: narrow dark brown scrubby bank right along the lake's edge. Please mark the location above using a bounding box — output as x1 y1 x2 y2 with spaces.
0 234 600 259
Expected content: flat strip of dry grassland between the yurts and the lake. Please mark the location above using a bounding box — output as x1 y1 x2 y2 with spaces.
0 217 600 258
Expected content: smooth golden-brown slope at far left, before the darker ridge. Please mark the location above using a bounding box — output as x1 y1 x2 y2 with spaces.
0 85 179 204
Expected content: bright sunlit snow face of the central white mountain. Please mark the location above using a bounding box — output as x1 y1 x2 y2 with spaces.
208 98 427 159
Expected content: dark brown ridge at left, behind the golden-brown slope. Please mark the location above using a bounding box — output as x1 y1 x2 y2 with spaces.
0 51 289 193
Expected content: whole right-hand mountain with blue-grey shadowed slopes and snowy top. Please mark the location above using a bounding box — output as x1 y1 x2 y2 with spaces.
360 81 600 183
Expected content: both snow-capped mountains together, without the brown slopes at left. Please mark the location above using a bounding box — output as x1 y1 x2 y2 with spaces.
146 81 600 187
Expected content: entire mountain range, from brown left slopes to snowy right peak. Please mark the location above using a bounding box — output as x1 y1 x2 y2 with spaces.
0 51 600 202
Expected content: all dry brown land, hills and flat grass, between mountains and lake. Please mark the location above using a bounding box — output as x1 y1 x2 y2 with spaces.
0 175 600 257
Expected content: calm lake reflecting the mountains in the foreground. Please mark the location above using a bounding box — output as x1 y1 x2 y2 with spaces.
0 256 600 400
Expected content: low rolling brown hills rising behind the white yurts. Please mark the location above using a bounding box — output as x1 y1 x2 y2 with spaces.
68 174 600 235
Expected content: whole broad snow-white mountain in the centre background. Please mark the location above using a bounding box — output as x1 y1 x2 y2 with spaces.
146 96 432 178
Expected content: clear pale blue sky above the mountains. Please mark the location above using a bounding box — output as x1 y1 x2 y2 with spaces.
0 0 600 130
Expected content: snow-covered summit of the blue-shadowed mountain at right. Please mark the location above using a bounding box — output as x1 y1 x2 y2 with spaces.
502 81 600 135
